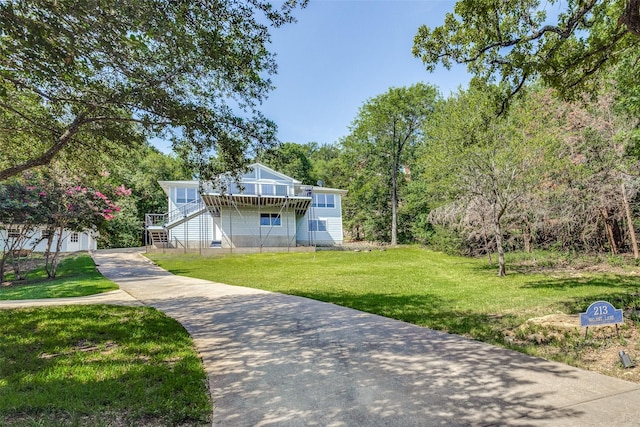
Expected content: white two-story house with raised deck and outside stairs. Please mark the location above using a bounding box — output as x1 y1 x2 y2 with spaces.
146 163 346 250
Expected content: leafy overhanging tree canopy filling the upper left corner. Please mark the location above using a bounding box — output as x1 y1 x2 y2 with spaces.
0 0 305 180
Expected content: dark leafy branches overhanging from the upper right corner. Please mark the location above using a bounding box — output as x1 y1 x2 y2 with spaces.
413 0 640 106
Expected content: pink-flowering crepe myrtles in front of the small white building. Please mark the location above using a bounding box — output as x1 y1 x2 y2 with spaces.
0 172 131 281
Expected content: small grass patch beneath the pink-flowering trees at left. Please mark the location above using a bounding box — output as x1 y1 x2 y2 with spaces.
0 254 118 300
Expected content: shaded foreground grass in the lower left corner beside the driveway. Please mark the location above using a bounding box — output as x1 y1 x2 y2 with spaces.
0 305 211 426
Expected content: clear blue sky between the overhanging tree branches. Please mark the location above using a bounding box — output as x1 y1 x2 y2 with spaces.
154 0 469 154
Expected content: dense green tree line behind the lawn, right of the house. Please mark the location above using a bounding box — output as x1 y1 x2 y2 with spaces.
263 72 640 274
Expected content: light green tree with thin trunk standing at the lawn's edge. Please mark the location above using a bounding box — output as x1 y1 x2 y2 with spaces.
421 83 559 275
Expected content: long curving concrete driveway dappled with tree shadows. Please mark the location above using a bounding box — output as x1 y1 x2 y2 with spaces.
20 251 640 427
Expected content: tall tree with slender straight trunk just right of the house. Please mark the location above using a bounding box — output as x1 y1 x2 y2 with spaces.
342 83 439 244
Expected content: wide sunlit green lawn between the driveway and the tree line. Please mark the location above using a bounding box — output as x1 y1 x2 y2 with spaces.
148 247 640 343
